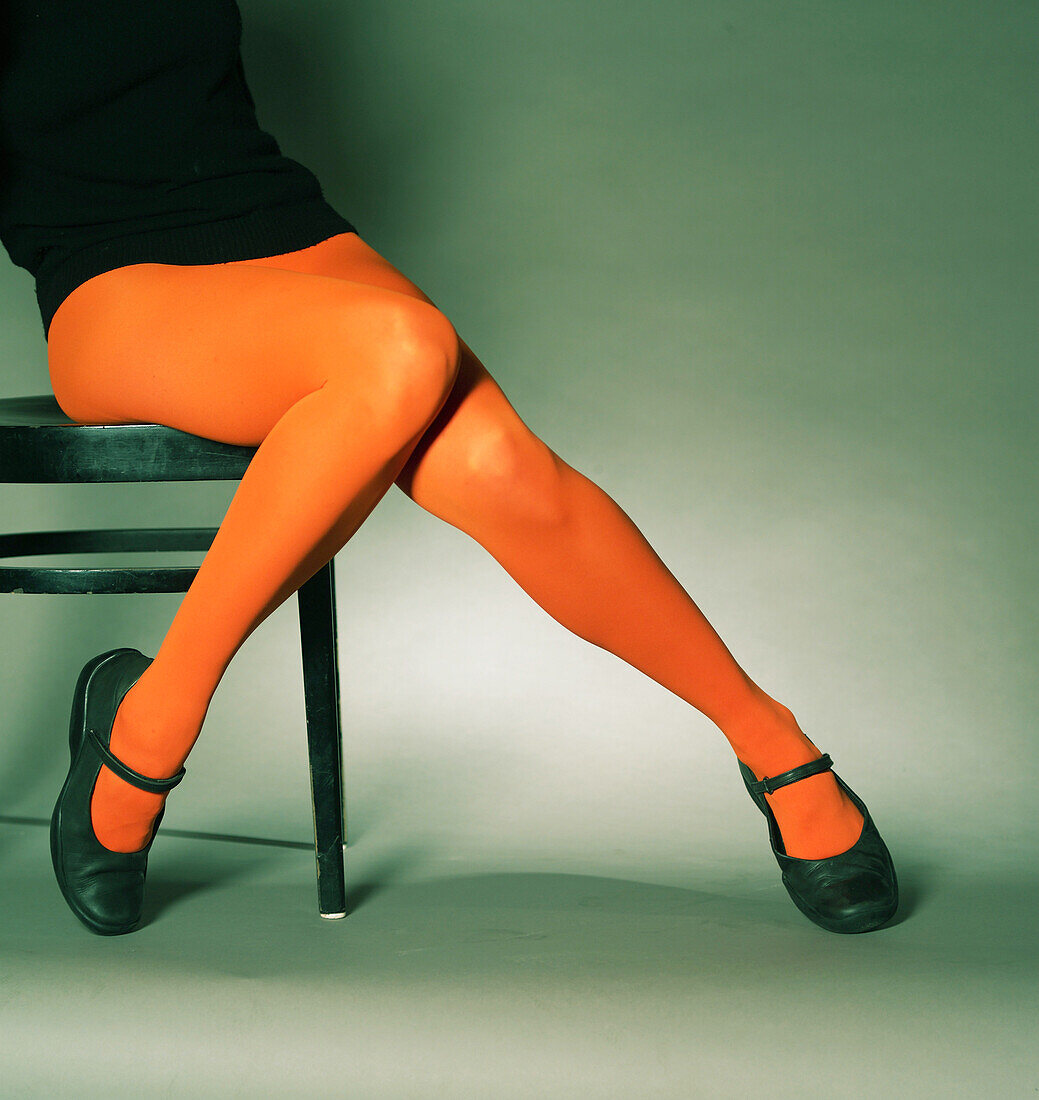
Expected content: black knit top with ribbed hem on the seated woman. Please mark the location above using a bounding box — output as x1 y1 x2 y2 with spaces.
0 0 355 339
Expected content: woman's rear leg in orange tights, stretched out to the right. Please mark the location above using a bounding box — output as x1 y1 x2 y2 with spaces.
301 238 862 858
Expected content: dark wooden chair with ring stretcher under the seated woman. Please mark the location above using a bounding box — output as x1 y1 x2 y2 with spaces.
0 394 346 919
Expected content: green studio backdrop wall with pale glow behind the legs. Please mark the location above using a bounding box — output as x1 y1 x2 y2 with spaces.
0 0 1039 1096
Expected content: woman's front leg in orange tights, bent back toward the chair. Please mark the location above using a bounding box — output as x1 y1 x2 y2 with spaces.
48 240 458 851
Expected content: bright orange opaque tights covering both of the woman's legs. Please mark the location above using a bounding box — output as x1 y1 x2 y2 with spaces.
47 233 862 858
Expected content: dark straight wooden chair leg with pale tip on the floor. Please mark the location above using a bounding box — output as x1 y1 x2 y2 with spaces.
296 559 346 919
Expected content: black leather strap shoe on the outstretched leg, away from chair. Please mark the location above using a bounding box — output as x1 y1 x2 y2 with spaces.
737 754 898 932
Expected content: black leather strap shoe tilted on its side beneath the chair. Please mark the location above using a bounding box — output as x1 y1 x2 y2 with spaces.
51 649 185 936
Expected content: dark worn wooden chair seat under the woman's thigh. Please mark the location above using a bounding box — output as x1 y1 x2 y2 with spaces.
0 394 256 484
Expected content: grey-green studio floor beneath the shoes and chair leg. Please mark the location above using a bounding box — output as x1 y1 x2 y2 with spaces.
0 802 1039 1100
